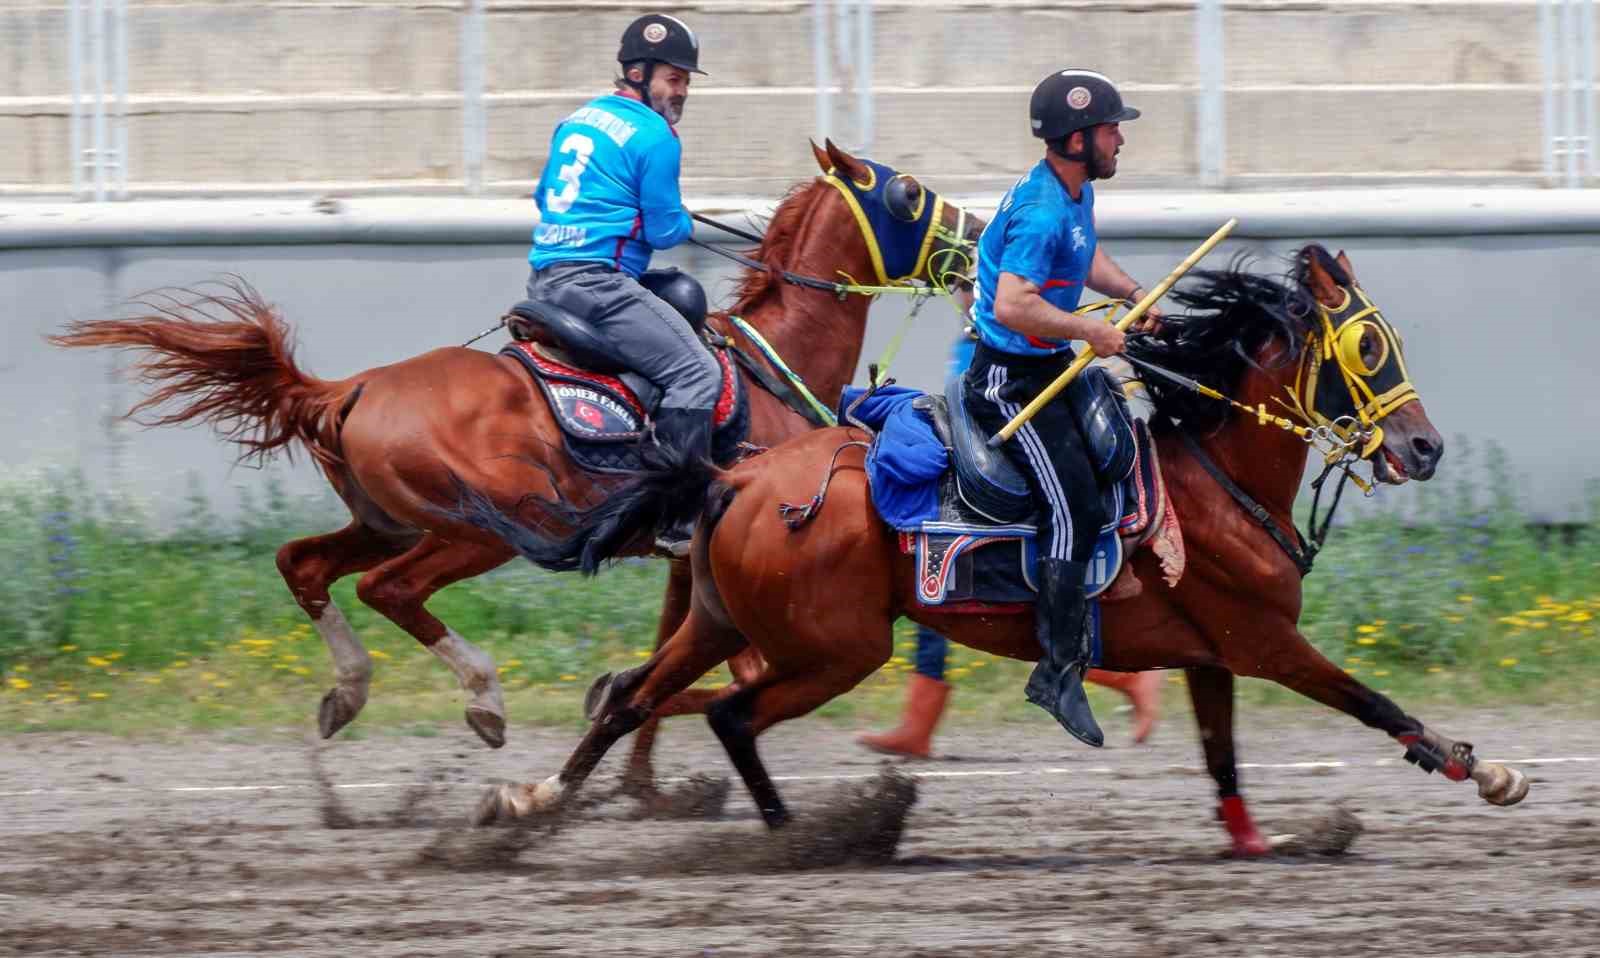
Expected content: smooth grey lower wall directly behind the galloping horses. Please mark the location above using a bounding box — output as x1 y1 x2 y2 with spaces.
0 192 1600 520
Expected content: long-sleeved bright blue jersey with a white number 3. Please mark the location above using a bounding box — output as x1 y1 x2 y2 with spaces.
528 94 694 278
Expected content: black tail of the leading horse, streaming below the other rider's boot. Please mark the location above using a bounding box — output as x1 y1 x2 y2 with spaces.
440 449 722 576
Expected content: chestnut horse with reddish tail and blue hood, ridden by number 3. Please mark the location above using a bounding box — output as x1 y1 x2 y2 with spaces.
51 142 984 782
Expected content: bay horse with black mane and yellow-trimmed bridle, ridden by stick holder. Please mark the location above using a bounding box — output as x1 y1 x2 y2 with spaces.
464 245 1528 856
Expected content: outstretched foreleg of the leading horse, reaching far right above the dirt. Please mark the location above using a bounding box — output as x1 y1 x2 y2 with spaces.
1243 632 1528 804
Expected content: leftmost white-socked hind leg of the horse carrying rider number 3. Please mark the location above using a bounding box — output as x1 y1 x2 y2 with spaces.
277 521 408 739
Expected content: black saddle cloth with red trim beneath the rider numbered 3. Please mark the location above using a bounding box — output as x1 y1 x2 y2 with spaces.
501 342 750 473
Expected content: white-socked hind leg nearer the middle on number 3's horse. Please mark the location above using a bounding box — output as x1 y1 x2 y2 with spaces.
355 534 514 748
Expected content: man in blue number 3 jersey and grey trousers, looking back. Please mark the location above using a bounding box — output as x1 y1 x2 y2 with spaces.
528 13 722 555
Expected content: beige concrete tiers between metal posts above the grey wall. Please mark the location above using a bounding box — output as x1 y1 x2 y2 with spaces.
0 0 1541 195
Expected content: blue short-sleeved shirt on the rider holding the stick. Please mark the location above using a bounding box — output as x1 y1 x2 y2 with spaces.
973 160 1098 355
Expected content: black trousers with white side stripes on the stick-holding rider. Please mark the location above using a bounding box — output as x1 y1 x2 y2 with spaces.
963 344 1106 563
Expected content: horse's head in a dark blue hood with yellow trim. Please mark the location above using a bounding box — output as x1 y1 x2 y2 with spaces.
811 141 984 286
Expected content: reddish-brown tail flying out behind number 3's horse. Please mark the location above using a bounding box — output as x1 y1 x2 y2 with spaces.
50 280 358 469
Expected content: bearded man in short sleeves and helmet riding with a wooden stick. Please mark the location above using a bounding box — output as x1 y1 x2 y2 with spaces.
965 70 1160 747
